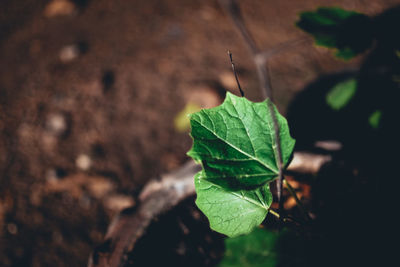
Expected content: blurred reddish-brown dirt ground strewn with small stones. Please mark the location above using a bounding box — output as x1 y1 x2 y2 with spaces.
0 0 400 266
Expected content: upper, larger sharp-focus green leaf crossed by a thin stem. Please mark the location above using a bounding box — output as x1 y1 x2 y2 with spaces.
188 93 295 189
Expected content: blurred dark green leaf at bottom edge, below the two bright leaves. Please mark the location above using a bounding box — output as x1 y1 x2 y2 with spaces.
219 229 279 267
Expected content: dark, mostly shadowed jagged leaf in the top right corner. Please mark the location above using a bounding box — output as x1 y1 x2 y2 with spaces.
296 7 373 60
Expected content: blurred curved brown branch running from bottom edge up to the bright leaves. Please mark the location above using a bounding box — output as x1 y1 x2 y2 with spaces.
88 161 201 267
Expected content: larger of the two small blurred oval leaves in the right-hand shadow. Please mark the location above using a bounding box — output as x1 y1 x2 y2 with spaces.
326 79 357 110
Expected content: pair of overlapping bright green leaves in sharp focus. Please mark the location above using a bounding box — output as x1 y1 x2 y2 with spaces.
188 93 295 236
